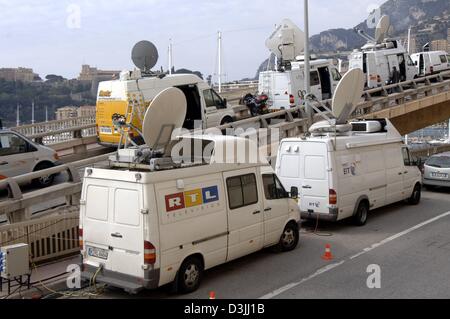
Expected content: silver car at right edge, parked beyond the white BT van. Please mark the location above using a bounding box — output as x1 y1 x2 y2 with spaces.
423 152 450 187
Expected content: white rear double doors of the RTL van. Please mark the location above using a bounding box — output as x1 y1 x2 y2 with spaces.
81 179 144 277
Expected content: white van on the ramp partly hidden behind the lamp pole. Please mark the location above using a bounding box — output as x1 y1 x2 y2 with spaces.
258 59 341 111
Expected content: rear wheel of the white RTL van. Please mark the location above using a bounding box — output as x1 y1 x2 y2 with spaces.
177 257 203 294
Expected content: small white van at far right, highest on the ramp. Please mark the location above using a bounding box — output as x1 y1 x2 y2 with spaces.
411 51 450 76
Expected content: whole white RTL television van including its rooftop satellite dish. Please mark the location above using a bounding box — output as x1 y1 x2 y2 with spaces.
80 88 300 293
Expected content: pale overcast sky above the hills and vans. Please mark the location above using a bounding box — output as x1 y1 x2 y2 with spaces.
0 0 384 80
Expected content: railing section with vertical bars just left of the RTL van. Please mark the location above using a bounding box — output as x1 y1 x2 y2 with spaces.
0 209 80 263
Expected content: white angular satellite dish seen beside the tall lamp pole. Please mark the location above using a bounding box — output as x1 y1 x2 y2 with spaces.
266 19 305 61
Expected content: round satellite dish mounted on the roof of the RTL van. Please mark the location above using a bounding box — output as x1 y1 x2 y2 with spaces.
142 87 187 150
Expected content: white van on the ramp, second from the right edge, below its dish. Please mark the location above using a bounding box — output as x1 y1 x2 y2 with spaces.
349 39 418 89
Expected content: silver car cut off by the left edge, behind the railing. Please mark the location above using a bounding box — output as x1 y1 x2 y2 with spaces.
0 130 60 187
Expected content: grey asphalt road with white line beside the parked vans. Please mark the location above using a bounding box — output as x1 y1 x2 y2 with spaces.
84 190 450 299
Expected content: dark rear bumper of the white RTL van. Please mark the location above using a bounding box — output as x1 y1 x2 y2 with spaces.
81 264 159 294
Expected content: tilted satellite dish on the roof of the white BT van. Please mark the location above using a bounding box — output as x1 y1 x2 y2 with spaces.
332 69 364 124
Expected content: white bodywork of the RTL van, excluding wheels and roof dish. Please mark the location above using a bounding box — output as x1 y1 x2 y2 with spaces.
80 136 300 291
